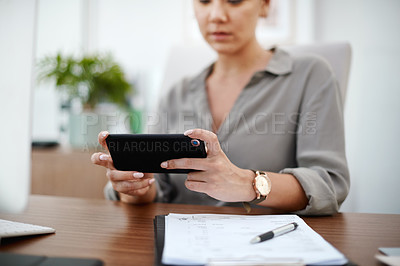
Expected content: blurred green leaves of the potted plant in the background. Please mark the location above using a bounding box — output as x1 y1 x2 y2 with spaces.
38 53 133 108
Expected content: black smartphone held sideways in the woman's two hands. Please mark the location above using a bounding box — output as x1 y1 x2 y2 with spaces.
106 134 207 173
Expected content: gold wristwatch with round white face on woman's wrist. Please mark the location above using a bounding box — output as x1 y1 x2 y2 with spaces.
243 170 271 213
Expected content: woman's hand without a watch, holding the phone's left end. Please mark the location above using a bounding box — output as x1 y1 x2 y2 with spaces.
91 131 156 203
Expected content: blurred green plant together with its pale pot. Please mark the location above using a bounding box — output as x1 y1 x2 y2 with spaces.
38 53 138 147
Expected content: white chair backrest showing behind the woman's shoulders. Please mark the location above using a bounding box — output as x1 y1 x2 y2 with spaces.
162 42 351 102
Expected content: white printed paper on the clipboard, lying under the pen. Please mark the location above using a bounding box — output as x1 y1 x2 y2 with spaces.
162 213 347 265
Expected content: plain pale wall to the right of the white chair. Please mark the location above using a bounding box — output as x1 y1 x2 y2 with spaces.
315 0 400 213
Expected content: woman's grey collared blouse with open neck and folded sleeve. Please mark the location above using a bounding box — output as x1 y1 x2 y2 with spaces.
108 49 350 215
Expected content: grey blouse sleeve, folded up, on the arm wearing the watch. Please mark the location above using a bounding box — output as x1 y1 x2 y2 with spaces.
281 56 350 215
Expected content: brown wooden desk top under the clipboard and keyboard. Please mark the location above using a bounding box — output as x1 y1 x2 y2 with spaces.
0 195 400 265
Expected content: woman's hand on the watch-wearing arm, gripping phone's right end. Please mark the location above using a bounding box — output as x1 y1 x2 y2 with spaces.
161 129 256 202
